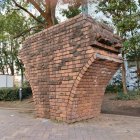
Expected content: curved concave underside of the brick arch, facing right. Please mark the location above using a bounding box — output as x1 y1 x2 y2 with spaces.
67 59 120 122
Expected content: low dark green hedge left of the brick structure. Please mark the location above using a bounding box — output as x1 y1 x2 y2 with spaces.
0 87 32 101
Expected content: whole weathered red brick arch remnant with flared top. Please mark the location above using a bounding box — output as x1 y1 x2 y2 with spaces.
20 15 121 123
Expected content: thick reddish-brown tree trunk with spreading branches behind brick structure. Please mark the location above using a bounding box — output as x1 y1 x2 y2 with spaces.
1 0 84 28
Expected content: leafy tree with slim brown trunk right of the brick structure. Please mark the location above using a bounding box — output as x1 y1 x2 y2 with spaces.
99 0 139 94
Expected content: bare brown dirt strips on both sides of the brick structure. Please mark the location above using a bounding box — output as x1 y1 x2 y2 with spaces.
0 94 140 117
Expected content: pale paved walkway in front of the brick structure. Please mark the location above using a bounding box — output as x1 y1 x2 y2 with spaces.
0 109 140 140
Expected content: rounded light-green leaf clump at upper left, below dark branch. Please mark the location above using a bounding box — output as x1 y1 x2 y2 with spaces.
0 11 28 41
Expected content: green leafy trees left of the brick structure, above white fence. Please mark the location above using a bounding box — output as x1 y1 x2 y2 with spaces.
0 11 27 75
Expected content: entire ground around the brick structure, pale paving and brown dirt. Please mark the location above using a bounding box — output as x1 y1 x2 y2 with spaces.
0 95 140 140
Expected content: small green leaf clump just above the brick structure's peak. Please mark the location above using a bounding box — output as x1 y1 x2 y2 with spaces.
62 6 81 18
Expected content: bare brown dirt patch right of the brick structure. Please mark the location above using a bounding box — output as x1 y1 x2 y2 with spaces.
101 94 140 117
